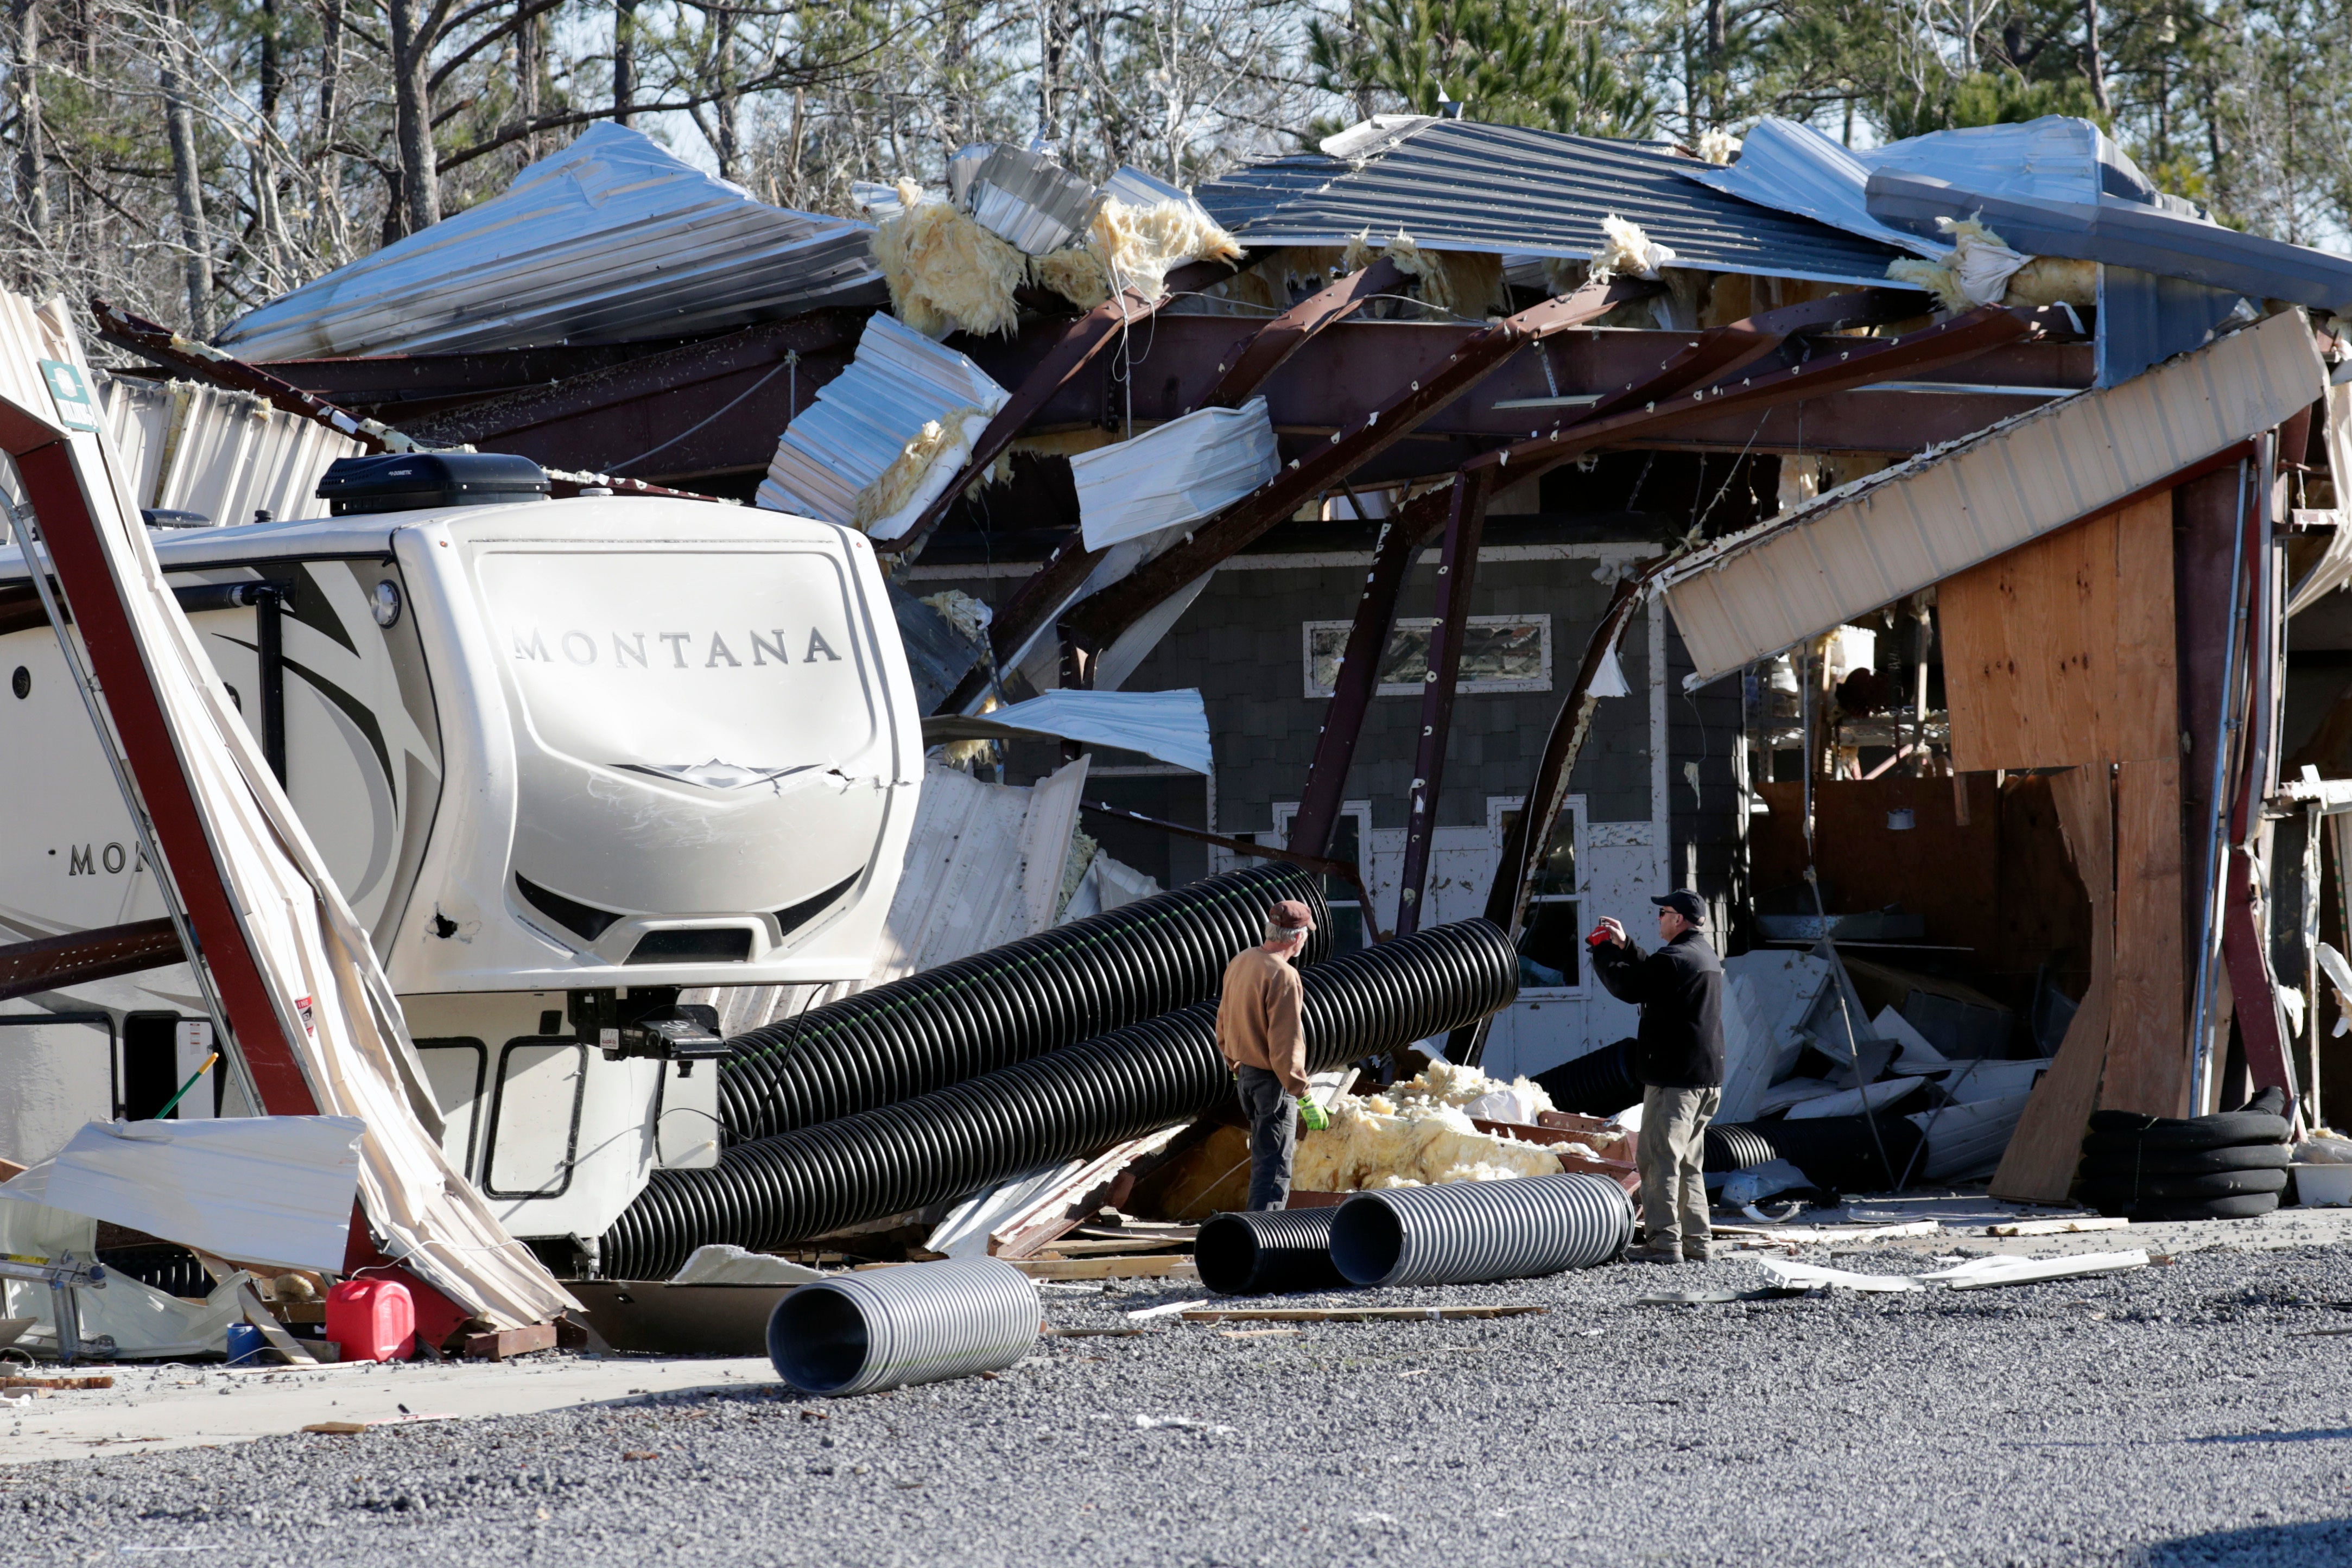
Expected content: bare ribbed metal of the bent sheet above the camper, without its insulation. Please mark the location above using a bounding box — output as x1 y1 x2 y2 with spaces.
760 310 1009 534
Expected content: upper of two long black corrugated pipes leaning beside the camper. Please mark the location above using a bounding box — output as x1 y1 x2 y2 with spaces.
720 863 1331 1142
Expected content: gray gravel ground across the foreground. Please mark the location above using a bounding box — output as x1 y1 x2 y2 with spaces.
0 1248 2352 1568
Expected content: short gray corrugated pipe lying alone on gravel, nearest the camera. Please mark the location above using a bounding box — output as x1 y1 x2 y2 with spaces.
767 1258 1044 1394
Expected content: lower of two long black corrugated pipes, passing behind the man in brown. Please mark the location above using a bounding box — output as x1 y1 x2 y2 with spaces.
602 919 1519 1279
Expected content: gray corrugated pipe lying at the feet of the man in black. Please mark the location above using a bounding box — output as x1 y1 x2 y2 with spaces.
1331 1173 1632 1286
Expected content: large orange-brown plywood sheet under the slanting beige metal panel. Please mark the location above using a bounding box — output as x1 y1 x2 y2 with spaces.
1936 494 2180 771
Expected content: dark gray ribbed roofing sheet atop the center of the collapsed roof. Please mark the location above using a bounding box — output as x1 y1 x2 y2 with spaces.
1197 120 1905 282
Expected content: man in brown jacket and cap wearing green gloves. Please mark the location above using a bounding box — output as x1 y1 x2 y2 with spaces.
1216 898 1315 1208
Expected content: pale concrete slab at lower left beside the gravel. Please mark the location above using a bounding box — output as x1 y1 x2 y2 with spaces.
0 1354 781 1464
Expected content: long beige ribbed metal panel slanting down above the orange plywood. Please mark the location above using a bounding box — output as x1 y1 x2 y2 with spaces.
1660 310 2326 684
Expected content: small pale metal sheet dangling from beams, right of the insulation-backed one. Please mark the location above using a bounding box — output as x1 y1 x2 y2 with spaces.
1070 397 1282 550
